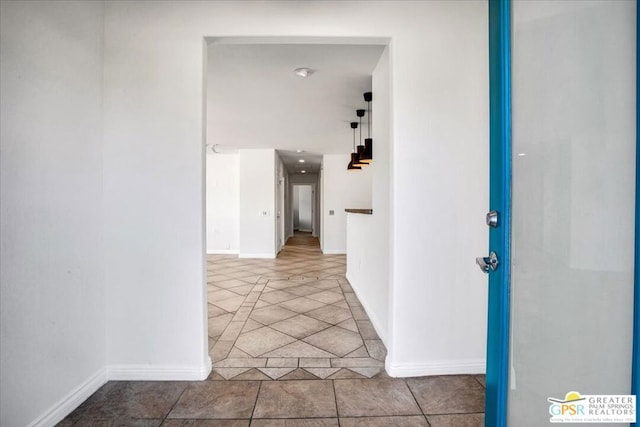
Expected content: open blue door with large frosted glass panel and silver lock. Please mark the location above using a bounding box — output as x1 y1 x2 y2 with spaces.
488 0 640 427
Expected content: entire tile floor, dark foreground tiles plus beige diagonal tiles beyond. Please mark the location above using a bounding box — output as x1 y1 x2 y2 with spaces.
59 234 484 427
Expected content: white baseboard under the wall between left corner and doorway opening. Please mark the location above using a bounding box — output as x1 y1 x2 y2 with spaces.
107 359 211 381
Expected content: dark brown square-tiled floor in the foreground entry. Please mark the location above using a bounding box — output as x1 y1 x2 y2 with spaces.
59 375 484 427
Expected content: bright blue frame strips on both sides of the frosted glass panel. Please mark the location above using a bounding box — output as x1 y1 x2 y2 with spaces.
485 0 640 427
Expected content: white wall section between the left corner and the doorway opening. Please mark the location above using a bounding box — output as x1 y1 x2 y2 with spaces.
103 2 210 379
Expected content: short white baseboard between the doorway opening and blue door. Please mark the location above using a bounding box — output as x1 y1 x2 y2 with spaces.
385 358 486 377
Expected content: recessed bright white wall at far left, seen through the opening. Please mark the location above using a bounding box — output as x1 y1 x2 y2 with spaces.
207 151 240 254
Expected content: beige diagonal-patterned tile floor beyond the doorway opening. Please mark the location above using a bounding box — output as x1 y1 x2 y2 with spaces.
208 235 387 380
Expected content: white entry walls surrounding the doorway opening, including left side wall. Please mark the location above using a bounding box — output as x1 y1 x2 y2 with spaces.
1 1 488 425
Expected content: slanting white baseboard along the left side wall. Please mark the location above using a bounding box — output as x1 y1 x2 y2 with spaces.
28 368 107 427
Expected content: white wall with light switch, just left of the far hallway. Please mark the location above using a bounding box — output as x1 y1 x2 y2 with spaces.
240 149 277 258
